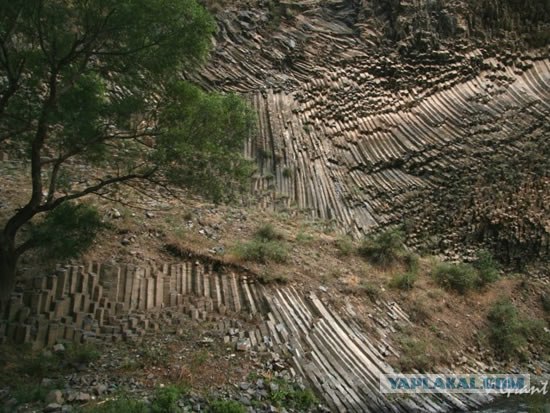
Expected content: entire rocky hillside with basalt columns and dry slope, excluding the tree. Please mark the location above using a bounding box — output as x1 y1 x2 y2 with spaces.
0 0 550 413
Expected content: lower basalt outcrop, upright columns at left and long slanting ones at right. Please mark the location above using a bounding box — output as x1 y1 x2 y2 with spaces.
0 260 496 412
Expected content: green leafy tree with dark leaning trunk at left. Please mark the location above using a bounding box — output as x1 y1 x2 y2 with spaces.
0 0 253 303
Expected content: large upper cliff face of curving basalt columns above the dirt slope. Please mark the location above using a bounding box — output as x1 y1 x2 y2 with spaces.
194 0 550 265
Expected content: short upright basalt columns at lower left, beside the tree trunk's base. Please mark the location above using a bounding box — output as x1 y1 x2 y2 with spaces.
0 261 263 348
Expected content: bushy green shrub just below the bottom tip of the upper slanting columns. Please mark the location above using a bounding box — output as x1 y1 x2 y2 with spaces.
358 228 405 267
